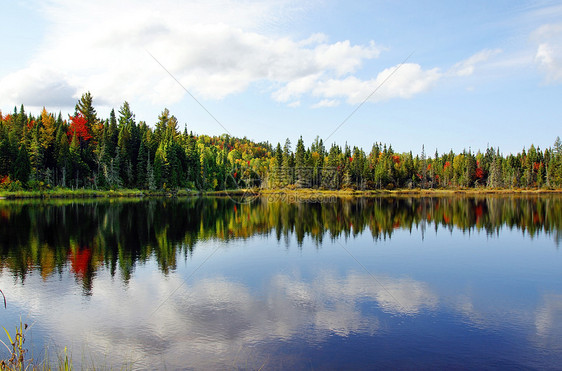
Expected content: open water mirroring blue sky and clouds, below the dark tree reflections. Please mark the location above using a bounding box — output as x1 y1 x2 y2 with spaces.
0 198 562 369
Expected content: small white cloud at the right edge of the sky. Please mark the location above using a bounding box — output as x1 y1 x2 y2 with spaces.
533 23 562 83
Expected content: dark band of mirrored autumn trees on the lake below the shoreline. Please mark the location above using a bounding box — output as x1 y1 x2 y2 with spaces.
0 196 562 294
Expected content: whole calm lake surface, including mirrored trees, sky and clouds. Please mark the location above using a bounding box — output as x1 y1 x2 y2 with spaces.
0 196 562 370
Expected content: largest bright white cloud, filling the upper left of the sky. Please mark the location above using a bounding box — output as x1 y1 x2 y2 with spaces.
0 0 380 110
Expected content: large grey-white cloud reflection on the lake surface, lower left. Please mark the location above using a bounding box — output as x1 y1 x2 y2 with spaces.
0 271 438 368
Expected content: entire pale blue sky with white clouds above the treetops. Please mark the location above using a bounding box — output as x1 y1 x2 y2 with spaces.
0 0 562 154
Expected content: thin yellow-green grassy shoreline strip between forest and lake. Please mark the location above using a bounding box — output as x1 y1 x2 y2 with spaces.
0 188 562 200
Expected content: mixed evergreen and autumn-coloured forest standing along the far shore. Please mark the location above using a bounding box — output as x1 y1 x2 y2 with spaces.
0 92 562 191
